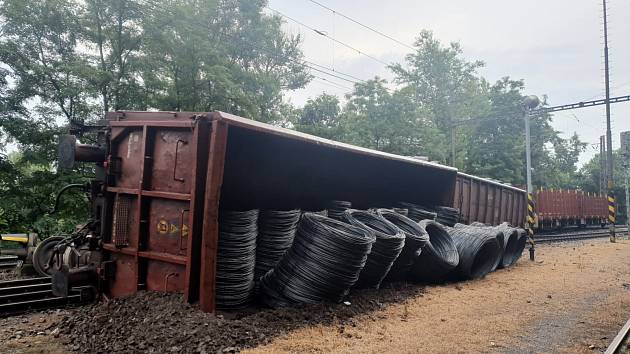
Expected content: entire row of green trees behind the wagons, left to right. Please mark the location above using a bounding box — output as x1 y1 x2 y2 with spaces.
0 0 584 235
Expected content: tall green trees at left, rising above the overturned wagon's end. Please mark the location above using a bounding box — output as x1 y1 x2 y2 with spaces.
0 0 310 234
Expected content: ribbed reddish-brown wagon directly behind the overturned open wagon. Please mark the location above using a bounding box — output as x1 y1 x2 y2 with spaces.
453 172 527 227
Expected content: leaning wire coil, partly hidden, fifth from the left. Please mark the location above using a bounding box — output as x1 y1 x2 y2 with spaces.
377 209 429 281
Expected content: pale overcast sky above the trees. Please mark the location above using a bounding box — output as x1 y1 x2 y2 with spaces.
269 0 630 167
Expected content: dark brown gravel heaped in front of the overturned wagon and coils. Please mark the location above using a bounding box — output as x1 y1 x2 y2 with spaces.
59 284 423 353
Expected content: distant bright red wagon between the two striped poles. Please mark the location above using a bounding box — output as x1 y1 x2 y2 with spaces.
536 189 608 230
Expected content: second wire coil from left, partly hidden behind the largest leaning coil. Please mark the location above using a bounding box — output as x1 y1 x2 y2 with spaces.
254 210 302 281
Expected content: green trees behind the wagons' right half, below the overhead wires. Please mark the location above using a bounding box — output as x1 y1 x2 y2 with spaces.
295 31 585 188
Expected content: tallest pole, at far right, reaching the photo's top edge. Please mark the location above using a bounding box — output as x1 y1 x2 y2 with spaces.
602 0 616 242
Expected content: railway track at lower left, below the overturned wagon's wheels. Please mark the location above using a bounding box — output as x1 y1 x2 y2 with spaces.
0 277 94 318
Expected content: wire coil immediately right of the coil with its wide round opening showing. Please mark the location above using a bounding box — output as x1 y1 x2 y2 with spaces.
450 225 503 279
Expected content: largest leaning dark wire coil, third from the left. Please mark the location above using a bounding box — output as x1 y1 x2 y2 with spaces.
260 213 376 307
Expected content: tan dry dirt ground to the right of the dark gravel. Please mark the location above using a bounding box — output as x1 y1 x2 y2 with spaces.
247 240 630 353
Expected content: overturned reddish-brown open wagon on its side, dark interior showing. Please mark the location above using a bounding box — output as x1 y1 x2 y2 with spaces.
100 112 460 311
